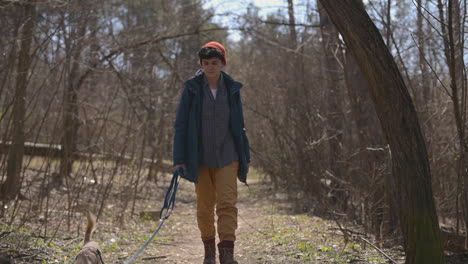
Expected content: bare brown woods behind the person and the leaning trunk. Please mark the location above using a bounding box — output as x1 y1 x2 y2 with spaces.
0 0 468 260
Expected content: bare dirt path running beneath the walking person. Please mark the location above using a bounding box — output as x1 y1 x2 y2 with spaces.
124 178 264 263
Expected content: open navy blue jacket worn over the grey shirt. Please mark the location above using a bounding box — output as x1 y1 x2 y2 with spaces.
173 71 250 183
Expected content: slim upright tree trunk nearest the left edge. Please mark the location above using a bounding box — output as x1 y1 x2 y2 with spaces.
0 0 36 199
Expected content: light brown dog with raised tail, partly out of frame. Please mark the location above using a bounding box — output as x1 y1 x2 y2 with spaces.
74 210 104 264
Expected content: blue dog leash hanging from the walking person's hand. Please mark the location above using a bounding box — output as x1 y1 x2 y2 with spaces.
124 168 184 264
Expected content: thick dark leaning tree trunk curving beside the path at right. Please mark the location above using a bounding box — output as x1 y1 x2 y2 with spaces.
321 0 445 264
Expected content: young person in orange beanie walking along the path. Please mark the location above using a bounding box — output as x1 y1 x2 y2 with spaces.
174 41 250 264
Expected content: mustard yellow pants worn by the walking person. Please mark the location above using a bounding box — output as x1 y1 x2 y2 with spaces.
195 161 239 241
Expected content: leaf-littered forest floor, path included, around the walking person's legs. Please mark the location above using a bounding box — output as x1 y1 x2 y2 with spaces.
0 165 464 264
